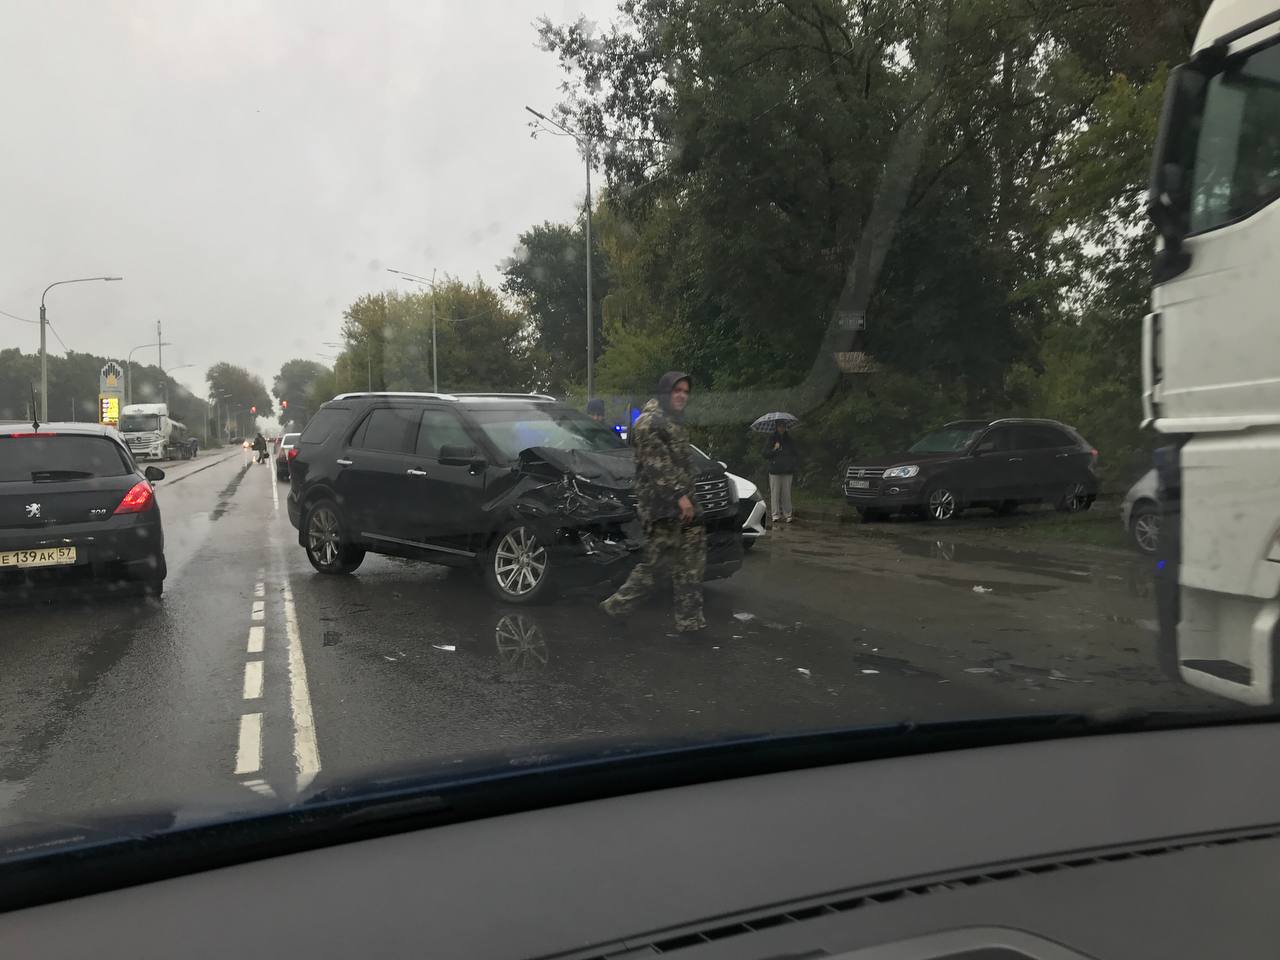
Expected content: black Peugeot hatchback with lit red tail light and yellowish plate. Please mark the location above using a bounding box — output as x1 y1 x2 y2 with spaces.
0 424 166 596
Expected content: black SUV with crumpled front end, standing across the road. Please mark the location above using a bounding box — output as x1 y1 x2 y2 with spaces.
280 393 742 603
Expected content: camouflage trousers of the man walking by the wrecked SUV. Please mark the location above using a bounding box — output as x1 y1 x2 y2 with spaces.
600 520 707 630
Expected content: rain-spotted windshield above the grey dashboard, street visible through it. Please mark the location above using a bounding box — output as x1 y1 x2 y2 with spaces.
0 0 1264 885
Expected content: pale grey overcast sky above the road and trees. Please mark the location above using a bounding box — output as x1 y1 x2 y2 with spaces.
0 0 616 404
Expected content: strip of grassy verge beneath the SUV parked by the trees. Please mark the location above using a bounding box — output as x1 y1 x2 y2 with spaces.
793 490 1133 550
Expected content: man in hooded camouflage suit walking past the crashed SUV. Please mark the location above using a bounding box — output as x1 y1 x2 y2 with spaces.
600 371 707 632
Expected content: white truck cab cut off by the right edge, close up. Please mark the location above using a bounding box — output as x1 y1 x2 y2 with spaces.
1143 0 1280 704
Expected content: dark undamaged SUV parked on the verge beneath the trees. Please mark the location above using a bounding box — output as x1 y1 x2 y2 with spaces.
844 420 1098 521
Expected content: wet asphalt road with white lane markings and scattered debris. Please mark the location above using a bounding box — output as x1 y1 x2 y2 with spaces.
0 451 1208 826
